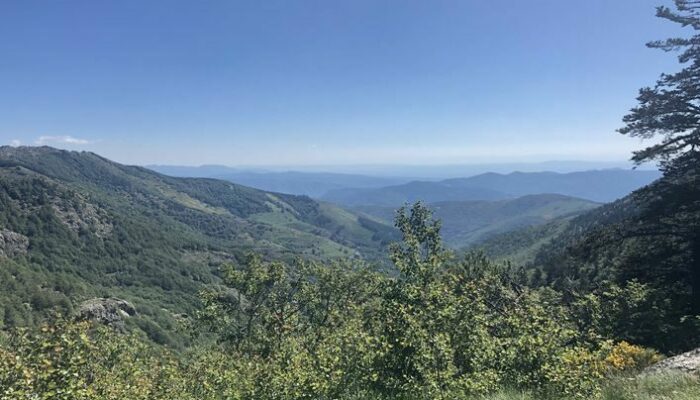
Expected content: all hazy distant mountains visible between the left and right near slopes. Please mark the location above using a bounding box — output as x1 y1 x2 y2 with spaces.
146 165 661 248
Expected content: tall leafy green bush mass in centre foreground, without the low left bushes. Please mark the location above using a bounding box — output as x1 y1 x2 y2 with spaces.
193 204 668 399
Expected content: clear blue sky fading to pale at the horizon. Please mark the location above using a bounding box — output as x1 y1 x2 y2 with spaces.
0 0 681 165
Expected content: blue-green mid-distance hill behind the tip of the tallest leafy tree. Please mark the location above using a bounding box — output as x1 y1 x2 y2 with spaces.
354 194 599 248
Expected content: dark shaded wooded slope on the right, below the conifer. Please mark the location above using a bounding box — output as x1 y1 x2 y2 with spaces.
474 158 700 352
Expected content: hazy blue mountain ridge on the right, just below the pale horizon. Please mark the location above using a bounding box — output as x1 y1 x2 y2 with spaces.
322 169 661 206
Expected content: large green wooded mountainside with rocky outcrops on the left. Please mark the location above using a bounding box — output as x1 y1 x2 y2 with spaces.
0 147 392 342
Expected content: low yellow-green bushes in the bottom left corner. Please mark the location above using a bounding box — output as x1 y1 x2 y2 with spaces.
0 321 245 400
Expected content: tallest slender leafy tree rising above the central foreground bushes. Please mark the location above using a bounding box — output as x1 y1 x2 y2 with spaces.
376 203 453 393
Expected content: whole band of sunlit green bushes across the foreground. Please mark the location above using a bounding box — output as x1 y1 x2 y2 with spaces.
0 204 684 400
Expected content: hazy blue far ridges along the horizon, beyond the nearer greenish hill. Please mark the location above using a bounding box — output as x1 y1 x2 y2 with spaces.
148 165 661 206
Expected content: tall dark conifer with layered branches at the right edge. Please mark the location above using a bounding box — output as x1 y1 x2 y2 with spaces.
619 0 700 322
